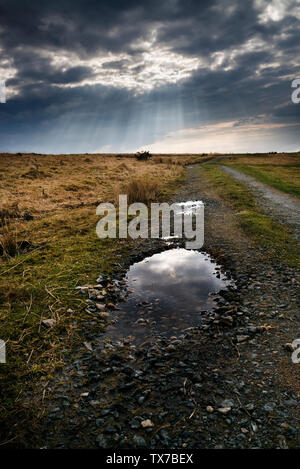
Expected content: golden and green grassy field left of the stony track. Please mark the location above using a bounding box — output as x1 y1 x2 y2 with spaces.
0 154 206 440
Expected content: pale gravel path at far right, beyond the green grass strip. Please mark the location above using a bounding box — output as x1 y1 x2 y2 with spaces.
221 166 300 240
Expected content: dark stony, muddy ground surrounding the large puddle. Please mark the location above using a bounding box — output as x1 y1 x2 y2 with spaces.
23 163 300 448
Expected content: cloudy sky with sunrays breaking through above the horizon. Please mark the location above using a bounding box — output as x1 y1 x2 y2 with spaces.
0 0 300 153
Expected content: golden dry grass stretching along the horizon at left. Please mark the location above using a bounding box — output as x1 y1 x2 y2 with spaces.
0 154 202 223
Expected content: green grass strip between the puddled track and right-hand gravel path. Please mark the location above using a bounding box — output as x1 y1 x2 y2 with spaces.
199 164 300 267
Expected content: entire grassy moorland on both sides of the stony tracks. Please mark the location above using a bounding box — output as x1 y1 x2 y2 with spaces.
0 154 300 445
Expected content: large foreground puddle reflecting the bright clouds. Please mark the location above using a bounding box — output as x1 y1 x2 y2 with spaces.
107 248 233 343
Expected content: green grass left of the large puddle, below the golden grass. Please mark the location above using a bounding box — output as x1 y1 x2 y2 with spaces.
0 211 129 441
